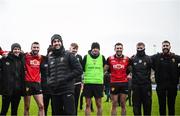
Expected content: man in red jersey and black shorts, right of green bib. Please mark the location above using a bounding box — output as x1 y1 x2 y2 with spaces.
106 43 129 116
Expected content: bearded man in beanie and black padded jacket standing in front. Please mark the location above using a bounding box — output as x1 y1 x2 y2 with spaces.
47 34 83 115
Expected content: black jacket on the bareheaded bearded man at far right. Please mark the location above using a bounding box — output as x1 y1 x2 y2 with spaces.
151 53 180 86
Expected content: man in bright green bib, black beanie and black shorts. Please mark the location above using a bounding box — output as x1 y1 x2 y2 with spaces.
82 42 106 116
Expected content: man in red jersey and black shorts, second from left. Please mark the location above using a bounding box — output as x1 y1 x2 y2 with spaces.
24 42 44 116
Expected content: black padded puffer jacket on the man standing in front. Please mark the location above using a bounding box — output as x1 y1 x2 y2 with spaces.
47 48 83 95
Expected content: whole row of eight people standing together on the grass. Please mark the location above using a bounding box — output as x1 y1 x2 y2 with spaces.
0 34 180 116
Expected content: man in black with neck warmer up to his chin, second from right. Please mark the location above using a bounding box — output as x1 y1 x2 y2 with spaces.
130 42 152 115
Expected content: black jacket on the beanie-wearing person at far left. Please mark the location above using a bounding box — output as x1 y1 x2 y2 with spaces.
0 52 25 96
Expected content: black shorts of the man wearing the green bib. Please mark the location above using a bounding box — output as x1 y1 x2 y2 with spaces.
83 84 103 98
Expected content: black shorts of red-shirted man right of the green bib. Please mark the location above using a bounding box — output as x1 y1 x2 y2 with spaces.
110 83 128 95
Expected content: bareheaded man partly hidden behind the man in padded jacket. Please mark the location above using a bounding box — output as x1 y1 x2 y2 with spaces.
69 43 82 115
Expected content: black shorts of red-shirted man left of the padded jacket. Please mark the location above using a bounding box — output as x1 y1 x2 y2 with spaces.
25 82 42 96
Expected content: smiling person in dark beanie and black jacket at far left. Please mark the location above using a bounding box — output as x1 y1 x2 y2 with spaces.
0 43 24 115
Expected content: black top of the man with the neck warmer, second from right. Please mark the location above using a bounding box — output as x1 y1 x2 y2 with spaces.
130 55 152 85
